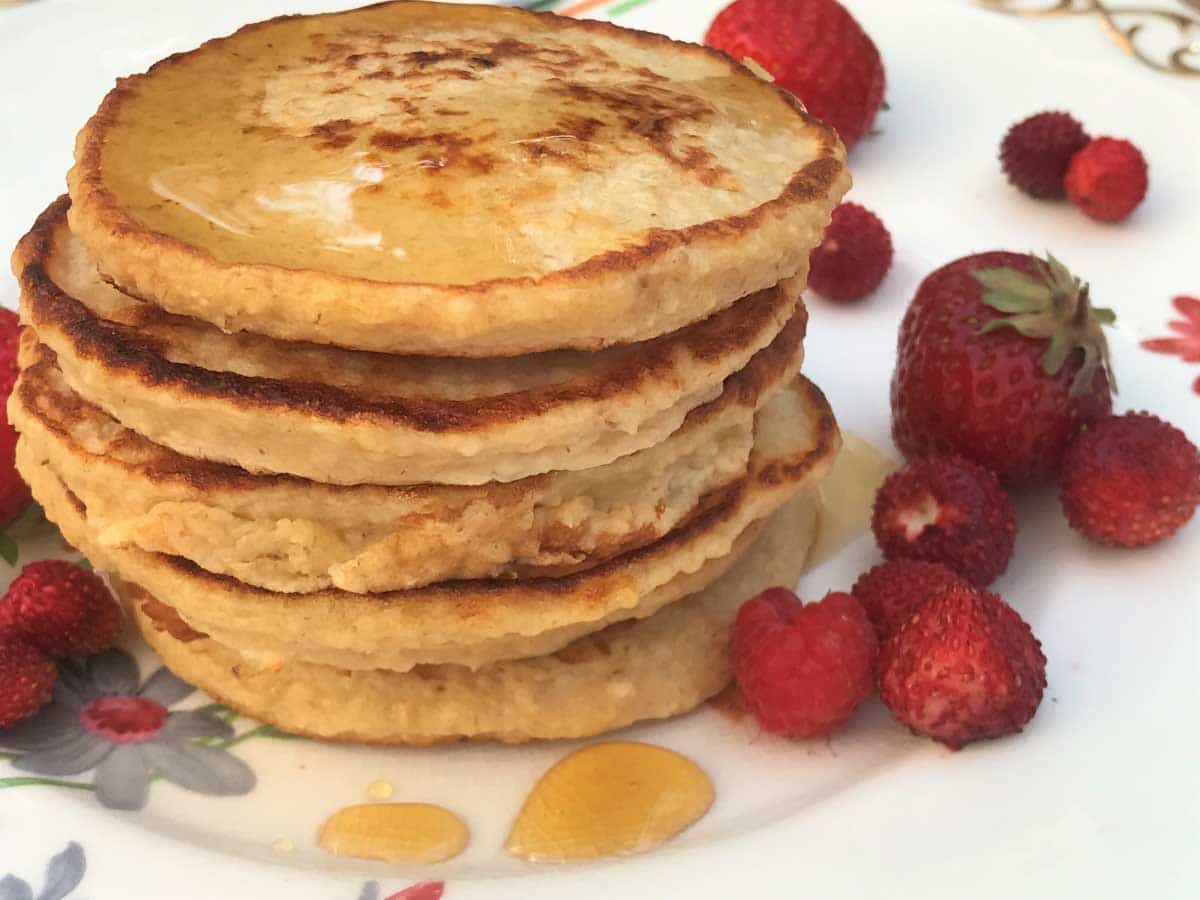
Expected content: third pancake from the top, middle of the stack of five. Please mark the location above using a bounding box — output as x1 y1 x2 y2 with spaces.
10 340 784 593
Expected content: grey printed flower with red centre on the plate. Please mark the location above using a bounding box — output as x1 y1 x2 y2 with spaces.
0 648 260 811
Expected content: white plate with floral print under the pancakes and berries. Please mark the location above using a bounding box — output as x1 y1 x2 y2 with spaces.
0 0 1200 900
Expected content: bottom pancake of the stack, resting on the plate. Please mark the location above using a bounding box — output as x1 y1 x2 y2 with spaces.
118 494 816 744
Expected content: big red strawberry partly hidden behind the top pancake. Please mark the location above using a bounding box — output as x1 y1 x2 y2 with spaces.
704 0 884 149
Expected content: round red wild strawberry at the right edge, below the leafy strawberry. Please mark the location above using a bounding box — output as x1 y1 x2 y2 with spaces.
1061 413 1200 547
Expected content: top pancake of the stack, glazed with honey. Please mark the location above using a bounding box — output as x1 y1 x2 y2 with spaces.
70 2 848 356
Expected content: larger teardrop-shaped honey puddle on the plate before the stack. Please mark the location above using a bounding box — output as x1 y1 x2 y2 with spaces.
505 742 713 863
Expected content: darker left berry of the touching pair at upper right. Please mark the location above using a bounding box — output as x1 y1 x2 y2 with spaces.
1000 113 1091 198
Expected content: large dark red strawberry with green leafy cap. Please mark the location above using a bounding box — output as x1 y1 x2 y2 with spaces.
892 251 1115 484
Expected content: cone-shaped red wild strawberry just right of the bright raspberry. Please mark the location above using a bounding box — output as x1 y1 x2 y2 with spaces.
878 587 1046 750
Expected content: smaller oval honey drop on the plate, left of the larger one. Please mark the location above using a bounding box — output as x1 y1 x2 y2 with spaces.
317 803 470 863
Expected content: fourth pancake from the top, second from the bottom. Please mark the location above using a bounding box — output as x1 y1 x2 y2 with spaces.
17 380 840 671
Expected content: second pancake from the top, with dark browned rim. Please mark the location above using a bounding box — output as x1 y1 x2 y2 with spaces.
13 199 806 485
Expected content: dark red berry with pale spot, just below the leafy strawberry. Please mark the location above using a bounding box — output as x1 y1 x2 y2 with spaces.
871 456 1016 587
